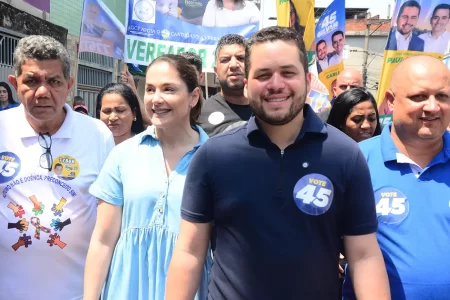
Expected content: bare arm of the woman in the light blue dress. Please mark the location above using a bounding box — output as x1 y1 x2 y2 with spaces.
83 199 122 300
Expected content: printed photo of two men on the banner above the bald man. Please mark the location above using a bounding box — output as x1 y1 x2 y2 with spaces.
386 0 450 54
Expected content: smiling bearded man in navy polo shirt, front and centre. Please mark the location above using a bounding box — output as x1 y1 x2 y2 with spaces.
166 27 389 300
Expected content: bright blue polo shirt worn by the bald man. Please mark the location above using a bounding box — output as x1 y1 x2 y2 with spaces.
344 125 450 300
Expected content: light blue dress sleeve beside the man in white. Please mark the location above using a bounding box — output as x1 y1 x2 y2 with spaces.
89 147 123 206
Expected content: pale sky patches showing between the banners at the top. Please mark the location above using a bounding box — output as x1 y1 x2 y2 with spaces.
263 0 395 27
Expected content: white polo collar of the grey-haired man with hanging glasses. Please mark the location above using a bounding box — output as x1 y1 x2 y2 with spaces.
17 103 74 138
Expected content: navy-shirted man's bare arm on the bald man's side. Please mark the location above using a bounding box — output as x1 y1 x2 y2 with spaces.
344 233 391 300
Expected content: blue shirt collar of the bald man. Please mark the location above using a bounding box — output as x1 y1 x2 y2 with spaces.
381 123 450 165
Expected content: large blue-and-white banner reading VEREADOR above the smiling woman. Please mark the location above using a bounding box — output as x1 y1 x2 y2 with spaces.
124 0 262 72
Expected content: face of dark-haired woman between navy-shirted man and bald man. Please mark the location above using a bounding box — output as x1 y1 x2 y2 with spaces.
344 100 378 142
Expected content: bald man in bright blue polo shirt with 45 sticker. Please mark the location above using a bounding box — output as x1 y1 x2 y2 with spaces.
344 56 450 300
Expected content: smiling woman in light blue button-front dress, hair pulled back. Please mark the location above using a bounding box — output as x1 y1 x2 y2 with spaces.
83 54 212 300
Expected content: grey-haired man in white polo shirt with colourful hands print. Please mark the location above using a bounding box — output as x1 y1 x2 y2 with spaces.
0 36 114 300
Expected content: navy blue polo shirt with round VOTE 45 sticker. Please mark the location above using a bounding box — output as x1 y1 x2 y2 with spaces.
181 105 377 300
